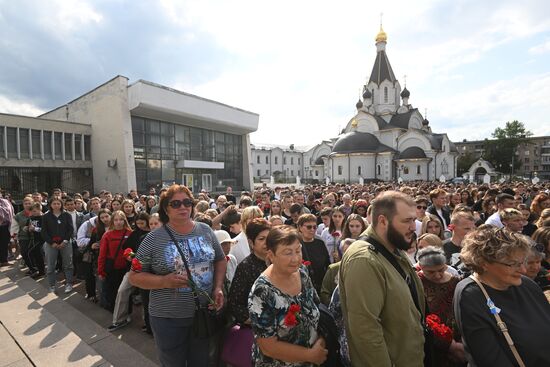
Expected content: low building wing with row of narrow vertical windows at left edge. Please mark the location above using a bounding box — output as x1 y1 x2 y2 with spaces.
0 114 93 197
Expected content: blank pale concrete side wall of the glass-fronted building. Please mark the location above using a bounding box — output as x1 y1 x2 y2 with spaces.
40 76 136 192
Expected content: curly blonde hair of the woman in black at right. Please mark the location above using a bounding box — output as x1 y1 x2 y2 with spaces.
460 226 530 274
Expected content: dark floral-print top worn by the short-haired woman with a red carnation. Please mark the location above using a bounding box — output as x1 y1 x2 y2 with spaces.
248 268 320 367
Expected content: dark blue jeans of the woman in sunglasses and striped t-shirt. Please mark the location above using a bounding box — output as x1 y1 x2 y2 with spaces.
149 315 208 367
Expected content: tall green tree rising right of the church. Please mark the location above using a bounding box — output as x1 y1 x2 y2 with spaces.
484 120 533 174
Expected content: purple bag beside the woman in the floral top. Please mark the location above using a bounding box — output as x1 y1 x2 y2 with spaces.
221 325 254 367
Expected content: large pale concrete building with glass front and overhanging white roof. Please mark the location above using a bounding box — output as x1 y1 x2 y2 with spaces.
40 76 259 193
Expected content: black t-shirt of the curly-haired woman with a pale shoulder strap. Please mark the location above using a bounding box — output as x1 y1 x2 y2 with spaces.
454 277 550 367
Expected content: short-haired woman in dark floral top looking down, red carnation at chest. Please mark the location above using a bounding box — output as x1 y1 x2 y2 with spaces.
248 226 328 367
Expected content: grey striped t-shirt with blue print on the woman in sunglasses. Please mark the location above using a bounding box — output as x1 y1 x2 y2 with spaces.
136 222 225 318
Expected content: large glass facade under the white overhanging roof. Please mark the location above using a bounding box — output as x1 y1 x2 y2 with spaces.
132 116 243 192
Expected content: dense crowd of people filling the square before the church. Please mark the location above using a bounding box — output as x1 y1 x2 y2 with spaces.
0 182 550 367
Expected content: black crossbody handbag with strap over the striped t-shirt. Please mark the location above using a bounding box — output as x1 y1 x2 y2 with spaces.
164 225 223 339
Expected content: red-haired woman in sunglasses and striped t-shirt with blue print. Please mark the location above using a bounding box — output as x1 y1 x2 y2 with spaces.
129 185 227 367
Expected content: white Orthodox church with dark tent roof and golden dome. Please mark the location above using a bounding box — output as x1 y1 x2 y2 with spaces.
303 26 458 183
